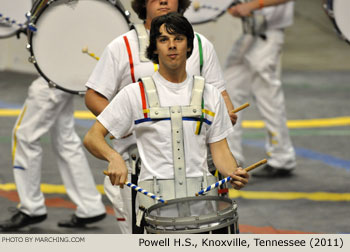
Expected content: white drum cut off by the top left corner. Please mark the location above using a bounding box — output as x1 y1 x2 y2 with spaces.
0 0 32 38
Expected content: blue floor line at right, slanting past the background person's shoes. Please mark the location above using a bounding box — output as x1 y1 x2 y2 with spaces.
243 140 350 171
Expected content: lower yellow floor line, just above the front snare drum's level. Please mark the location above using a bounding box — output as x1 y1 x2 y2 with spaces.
0 183 350 201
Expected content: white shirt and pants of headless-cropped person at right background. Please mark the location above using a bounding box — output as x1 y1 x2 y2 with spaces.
224 2 296 169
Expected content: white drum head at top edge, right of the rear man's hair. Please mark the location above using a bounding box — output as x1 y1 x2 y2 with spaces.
184 0 233 24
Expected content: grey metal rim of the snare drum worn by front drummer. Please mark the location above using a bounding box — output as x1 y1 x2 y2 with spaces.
145 196 237 227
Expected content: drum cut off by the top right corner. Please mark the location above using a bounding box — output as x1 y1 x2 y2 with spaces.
323 0 350 44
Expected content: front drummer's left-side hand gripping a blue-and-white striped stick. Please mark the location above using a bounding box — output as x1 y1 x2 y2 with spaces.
108 156 128 188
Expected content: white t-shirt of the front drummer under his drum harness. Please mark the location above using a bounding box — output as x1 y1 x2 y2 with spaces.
97 72 233 181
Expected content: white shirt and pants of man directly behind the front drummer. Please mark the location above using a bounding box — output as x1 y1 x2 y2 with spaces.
86 27 225 233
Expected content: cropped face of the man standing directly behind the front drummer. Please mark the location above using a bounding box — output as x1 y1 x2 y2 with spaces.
146 0 179 21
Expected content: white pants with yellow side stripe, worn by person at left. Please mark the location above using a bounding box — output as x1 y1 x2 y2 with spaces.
12 78 105 218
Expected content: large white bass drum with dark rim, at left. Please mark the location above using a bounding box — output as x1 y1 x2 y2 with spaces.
27 0 130 94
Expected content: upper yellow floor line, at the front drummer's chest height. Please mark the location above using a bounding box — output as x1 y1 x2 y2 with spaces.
0 109 350 129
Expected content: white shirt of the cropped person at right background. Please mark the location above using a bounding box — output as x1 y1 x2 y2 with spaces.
257 1 294 29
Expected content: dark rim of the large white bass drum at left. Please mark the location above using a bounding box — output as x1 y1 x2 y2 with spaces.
27 0 131 95
